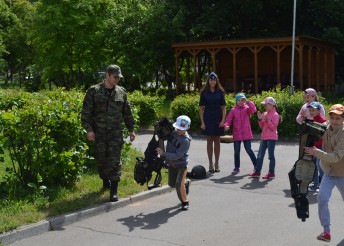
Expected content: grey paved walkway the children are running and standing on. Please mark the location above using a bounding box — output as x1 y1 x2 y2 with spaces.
0 134 344 246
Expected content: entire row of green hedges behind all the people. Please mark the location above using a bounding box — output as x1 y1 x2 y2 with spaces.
0 87 329 200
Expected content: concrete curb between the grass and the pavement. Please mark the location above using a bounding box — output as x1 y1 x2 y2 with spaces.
0 186 172 245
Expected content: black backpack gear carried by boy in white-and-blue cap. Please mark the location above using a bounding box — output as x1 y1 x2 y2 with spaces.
134 118 174 190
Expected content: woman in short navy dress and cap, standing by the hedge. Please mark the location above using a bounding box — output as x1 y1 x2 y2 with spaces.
199 72 226 173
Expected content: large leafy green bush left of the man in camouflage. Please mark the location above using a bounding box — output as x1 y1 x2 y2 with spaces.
0 90 87 193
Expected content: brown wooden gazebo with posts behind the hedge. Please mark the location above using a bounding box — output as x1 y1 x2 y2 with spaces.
172 36 335 93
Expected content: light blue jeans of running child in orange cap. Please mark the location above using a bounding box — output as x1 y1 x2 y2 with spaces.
318 175 344 232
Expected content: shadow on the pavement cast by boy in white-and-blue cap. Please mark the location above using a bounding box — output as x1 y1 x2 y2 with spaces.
117 205 182 231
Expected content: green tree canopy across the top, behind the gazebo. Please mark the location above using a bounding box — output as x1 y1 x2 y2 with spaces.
0 0 344 89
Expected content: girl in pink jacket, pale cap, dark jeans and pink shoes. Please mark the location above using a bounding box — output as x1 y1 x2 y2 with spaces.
249 97 281 179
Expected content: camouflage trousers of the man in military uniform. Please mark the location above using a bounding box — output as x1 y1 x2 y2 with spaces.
94 139 123 181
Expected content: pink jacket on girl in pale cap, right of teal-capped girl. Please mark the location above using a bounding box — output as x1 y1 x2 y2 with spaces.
258 108 280 140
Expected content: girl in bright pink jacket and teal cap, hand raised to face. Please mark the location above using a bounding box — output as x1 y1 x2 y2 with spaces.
224 93 257 175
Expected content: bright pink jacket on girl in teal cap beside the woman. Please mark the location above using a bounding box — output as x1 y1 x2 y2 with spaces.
224 101 257 141
